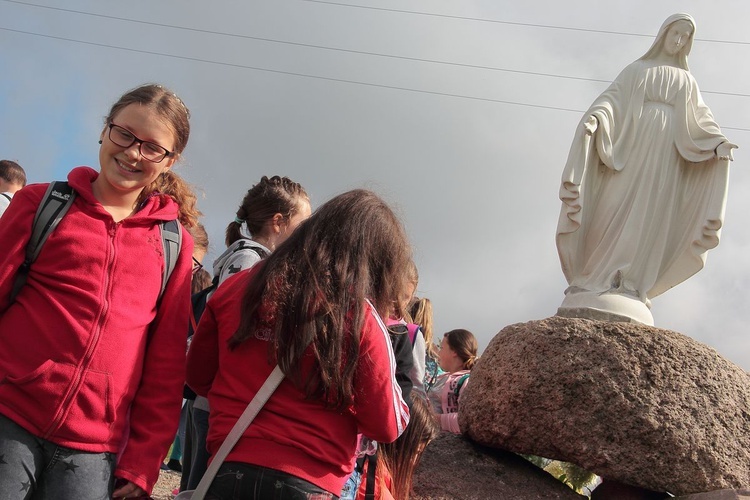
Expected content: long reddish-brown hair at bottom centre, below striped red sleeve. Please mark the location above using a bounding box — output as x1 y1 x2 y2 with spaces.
376 396 440 500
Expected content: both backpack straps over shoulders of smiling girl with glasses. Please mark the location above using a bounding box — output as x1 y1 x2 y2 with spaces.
10 181 182 302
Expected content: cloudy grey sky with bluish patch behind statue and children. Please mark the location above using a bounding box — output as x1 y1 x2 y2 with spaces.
0 0 750 370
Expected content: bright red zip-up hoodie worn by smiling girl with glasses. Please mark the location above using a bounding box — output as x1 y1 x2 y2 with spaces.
0 167 193 491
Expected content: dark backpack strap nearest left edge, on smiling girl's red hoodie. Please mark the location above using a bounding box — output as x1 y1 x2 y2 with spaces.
10 181 76 302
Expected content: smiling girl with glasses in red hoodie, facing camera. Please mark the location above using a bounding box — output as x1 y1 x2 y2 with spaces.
0 85 199 499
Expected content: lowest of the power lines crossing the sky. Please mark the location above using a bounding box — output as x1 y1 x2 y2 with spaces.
0 26 750 132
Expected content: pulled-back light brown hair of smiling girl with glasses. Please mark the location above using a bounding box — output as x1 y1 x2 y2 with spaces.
105 83 201 227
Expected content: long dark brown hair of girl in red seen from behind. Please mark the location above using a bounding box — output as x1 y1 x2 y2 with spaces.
229 189 411 409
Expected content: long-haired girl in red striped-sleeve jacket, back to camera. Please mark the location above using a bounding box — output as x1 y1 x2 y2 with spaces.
187 190 411 499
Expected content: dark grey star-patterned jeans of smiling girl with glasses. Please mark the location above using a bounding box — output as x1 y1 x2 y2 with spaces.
0 415 116 500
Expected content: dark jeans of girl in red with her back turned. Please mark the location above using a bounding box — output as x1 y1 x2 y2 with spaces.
206 462 338 500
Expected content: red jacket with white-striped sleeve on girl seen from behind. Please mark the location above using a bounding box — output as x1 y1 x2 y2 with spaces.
187 266 409 495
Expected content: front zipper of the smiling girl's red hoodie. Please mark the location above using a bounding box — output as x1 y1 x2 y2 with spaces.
42 222 120 439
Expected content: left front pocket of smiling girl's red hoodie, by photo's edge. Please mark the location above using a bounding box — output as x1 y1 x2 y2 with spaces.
0 359 75 432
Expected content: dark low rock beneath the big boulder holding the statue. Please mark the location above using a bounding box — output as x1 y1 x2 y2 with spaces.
409 432 586 500
